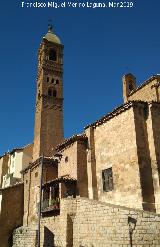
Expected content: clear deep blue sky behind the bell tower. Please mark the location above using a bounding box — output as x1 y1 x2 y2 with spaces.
0 0 160 154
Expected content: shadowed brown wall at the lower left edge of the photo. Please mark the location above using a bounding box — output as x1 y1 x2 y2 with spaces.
0 184 23 247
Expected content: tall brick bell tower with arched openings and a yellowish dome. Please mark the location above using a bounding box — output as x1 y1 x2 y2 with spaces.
33 25 63 161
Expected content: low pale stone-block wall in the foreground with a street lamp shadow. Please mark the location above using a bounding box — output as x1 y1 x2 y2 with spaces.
41 198 160 247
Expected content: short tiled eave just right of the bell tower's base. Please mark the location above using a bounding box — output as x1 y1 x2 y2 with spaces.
56 134 87 151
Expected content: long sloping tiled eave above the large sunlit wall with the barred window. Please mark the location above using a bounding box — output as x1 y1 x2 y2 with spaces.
85 100 146 129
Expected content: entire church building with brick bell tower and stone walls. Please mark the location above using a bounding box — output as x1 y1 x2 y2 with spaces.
0 26 160 247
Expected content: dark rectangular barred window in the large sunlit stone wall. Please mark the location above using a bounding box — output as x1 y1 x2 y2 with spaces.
102 168 113 192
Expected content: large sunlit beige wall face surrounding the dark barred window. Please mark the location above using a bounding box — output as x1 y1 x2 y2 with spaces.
94 104 142 208
